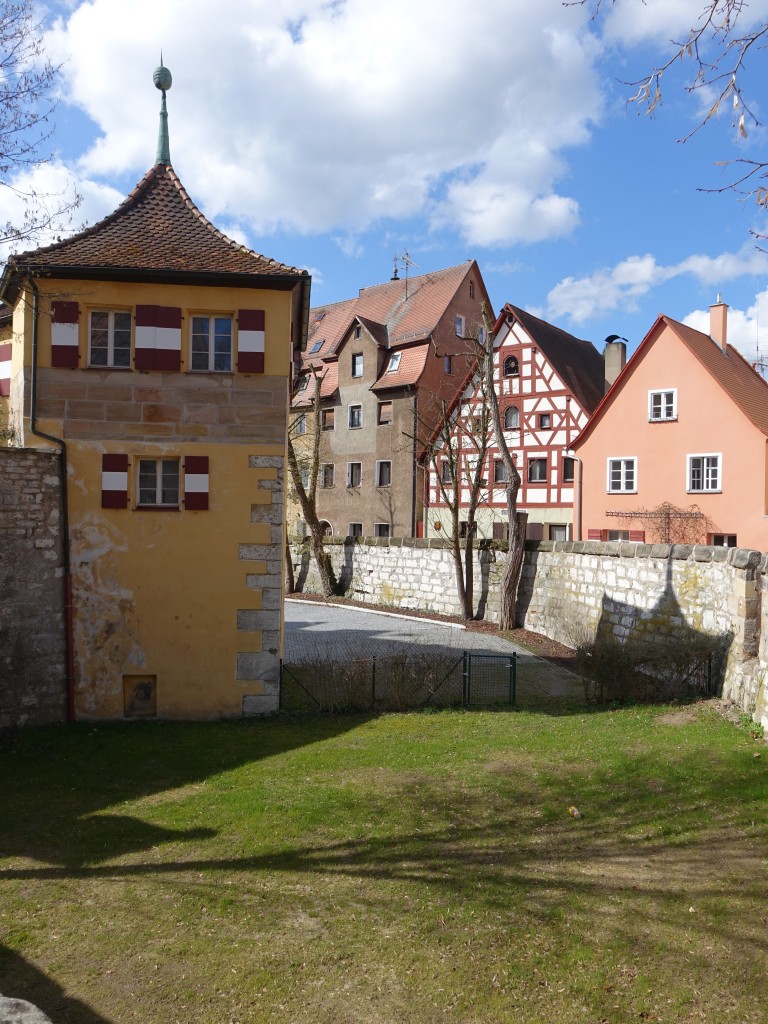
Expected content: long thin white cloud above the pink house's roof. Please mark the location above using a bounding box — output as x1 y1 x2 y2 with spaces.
547 243 768 324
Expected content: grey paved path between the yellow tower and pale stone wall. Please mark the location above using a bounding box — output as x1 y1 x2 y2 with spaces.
285 598 583 700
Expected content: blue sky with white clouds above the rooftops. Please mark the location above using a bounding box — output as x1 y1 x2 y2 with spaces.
0 0 768 364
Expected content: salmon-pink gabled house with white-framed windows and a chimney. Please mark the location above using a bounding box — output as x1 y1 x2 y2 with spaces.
572 302 768 551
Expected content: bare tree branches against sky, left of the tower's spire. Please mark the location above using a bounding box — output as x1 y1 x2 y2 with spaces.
0 0 80 243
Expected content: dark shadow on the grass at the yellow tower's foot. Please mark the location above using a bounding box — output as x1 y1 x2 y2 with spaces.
0 716 365 870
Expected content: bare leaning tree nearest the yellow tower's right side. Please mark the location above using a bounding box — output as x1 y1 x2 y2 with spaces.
288 367 338 597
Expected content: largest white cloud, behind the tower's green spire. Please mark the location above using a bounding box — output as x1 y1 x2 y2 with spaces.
41 0 601 247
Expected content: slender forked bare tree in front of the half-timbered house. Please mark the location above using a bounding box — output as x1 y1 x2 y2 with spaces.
427 394 490 618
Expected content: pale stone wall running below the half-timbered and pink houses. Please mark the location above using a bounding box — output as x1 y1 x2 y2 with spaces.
293 539 768 726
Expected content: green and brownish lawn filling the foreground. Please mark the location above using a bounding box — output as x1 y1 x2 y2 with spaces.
0 705 768 1024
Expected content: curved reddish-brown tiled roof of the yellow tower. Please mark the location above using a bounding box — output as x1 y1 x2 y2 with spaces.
6 164 306 278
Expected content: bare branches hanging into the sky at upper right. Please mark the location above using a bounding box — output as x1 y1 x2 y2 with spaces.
566 0 768 214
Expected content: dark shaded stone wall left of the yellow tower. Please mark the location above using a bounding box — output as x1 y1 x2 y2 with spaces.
0 449 66 729
